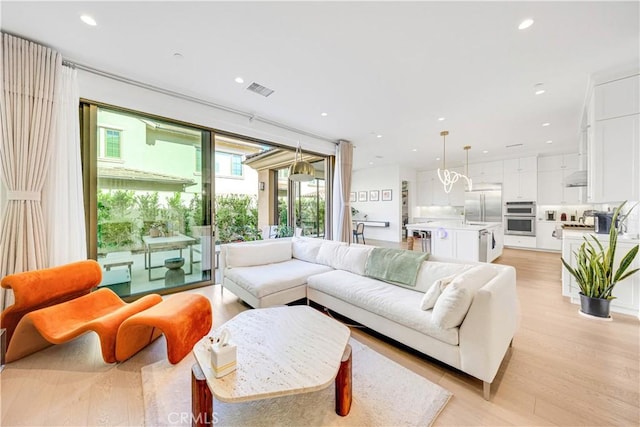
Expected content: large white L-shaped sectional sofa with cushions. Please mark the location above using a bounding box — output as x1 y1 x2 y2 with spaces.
220 237 518 399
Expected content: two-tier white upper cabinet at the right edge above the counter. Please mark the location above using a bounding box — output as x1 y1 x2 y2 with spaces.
587 74 640 203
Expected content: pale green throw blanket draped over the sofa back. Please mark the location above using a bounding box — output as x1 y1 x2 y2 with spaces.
364 248 429 287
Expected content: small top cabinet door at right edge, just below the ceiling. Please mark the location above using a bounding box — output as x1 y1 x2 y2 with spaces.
593 75 640 120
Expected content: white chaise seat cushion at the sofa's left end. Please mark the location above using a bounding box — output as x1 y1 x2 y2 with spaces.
224 259 332 298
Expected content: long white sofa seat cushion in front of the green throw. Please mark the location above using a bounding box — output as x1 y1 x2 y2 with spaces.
307 270 458 345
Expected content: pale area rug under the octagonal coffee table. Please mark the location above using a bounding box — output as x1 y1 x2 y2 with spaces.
142 339 451 427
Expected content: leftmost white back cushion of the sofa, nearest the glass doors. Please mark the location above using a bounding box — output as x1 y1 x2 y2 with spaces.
225 239 292 268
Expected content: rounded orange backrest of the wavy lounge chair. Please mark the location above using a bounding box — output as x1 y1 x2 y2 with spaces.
0 260 102 346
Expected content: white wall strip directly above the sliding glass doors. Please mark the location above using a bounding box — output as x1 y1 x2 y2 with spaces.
78 70 336 155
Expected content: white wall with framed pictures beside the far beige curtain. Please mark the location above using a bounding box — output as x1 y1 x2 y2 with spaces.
351 165 402 242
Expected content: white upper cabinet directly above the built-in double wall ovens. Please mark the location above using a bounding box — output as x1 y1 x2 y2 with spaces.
502 156 538 202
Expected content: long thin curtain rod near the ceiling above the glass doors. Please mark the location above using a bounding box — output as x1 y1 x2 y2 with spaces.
62 59 339 145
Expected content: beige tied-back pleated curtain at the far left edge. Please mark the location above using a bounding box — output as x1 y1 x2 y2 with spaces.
0 33 62 307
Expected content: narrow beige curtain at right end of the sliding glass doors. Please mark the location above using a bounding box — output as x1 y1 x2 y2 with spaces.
333 140 353 243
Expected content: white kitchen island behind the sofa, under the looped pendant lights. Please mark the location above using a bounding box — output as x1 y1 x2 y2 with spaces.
406 221 504 262
